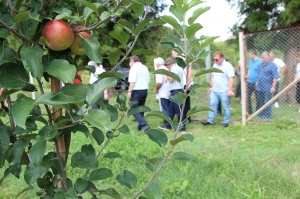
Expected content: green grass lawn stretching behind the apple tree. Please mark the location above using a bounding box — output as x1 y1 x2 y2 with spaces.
0 72 300 199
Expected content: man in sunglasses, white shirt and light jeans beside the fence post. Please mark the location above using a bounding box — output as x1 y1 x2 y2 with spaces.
201 51 234 127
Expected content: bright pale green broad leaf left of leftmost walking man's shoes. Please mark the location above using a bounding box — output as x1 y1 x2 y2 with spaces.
85 109 112 131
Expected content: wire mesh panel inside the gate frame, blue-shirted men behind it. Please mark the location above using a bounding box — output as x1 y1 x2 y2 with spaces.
243 27 300 122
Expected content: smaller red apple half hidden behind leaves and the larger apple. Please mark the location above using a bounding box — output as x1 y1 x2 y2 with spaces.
70 26 91 55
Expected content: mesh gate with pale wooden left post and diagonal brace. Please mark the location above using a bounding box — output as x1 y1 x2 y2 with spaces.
240 27 300 122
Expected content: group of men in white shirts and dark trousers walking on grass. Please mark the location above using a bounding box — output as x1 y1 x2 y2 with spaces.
128 51 193 132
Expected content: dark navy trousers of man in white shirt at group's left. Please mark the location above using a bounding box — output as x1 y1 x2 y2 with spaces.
130 90 148 130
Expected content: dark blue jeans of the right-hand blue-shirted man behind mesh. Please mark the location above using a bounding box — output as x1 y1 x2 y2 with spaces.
256 91 272 119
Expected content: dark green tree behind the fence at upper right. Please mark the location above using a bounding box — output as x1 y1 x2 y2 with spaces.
227 0 300 103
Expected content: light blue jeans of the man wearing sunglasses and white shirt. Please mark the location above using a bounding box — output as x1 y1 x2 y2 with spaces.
207 91 231 124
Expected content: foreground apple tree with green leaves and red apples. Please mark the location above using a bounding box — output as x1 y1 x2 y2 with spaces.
0 0 215 198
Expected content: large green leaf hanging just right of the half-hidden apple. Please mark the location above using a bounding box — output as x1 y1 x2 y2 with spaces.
80 34 103 63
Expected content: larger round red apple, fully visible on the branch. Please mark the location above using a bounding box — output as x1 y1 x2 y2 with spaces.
43 20 74 51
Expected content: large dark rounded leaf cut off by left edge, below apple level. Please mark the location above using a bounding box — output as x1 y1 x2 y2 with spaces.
0 63 30 89
